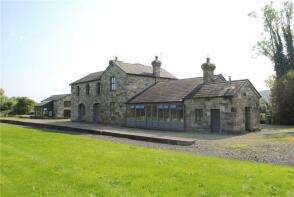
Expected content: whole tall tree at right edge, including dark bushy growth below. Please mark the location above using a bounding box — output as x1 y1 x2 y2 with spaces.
249 1 294 124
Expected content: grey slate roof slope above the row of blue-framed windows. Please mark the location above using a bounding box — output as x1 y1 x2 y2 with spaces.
128 75 223 103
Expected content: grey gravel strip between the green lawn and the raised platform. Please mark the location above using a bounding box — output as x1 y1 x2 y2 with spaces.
85 132 294 166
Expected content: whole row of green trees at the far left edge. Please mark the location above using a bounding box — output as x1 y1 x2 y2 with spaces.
0 88 36 116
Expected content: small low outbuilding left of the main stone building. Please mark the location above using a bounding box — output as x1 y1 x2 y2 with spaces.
35 94 71 118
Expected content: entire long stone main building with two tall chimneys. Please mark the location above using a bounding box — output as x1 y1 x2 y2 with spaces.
71 57 260 133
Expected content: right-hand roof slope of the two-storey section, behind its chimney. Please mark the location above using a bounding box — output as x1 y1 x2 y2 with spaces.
112 60 177 79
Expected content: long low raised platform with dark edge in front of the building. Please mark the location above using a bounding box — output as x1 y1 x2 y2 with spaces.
0 118 196 146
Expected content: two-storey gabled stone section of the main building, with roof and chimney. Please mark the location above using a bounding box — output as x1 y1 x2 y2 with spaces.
70 58 176 126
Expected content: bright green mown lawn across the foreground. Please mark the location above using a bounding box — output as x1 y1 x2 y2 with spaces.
0 125 294 197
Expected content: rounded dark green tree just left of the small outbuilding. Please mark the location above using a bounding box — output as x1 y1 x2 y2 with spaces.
13 97 36 115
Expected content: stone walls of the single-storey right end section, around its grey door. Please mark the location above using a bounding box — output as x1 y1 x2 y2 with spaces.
184 81 259 133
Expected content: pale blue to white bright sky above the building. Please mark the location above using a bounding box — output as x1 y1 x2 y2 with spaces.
0 0 280 102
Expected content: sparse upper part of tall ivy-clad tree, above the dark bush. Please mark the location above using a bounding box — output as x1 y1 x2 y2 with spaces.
249 1 294 78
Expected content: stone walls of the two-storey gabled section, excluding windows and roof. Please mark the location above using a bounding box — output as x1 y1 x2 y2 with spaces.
71 64 170 125
